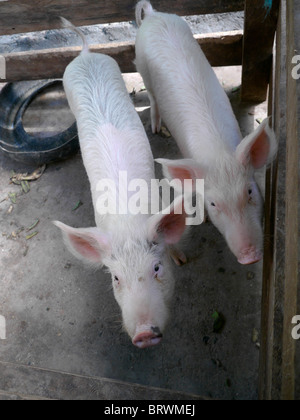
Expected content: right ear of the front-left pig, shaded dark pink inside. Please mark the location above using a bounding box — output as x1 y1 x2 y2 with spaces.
148 196 187 245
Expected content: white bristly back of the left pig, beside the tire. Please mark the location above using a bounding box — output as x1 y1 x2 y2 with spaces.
64 53 155 225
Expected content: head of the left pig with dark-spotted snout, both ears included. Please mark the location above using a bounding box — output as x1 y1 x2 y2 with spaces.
54 197 186 349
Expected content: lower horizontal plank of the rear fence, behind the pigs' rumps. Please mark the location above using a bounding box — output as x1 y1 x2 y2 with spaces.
0 31 243 82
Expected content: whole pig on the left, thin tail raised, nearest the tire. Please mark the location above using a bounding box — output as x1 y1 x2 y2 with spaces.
55 20 186 348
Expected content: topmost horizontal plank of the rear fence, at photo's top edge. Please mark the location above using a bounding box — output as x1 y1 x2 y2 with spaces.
0 0 244 35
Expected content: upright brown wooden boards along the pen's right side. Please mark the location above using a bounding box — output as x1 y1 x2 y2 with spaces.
259 0 300 400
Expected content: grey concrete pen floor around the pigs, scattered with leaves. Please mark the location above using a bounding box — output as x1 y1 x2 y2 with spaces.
0 68 266 399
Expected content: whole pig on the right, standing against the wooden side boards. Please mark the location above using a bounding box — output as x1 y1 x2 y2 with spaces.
136 1 277 264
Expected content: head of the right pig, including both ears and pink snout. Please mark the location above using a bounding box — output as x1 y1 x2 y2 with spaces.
158 119 277 264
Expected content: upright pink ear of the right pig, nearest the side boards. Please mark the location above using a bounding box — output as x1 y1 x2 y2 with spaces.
236 118 277 169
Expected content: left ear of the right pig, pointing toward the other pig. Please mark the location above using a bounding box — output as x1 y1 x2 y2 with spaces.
155 159 206 192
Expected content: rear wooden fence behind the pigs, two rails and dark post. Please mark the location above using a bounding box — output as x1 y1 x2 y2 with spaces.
0 0 280 102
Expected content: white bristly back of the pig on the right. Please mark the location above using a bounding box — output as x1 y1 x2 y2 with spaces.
136 13 242 159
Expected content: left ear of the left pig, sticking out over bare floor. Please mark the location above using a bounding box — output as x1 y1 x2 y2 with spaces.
53 222 110 266
